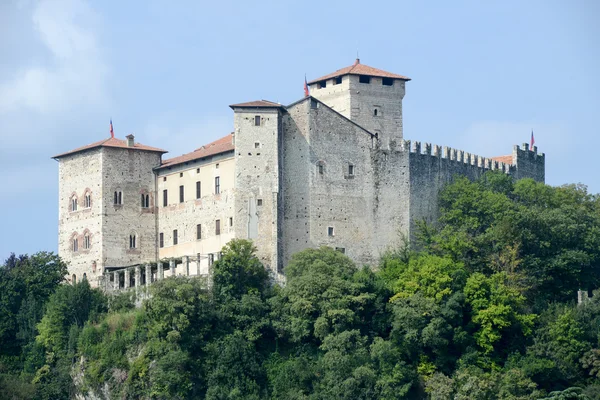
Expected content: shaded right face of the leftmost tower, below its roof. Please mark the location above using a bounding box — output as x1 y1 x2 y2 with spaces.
102 147 161 267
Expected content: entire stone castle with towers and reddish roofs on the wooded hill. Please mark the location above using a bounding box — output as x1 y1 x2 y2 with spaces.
53 59 545 287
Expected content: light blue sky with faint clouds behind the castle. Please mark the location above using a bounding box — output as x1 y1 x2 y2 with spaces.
0 0 600 260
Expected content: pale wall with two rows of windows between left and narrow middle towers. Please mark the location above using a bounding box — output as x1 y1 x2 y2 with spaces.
157 152 236 275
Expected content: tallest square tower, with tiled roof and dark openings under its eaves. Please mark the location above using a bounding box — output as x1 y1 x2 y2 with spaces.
309 59 410 149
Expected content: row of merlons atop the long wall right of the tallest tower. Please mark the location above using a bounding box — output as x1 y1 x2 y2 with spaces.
392 139 514 174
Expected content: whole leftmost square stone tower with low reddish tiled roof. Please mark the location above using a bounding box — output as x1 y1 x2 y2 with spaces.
53 135 166 286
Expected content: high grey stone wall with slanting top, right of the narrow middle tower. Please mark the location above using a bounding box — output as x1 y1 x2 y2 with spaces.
283 98 375 264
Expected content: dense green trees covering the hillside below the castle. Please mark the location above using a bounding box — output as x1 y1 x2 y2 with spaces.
0 173 600 400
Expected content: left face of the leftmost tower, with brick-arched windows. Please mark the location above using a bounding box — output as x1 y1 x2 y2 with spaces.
58 149 103 284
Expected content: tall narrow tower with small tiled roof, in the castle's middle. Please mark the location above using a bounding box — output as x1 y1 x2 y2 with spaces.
230 100 285 272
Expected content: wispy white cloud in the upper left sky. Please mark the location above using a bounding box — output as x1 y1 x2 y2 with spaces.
0 0 108 115
